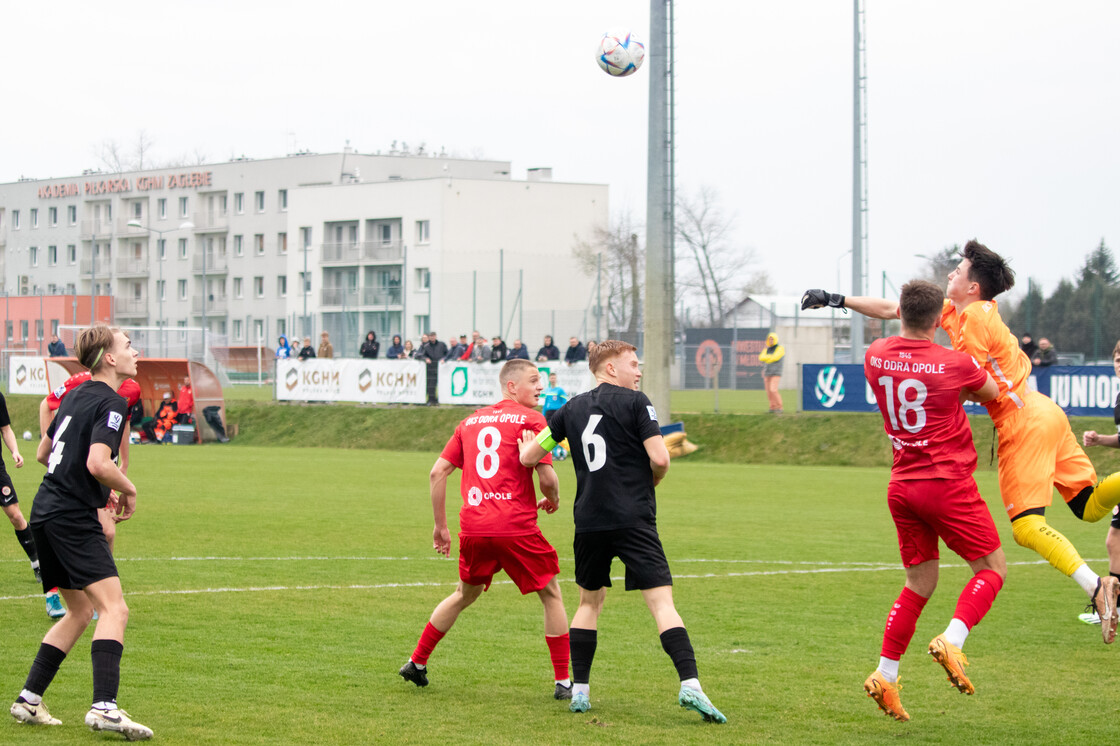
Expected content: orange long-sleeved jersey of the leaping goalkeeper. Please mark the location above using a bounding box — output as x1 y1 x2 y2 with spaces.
941 299 1030 427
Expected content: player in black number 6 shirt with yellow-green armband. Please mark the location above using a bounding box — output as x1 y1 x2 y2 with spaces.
521 339 727 722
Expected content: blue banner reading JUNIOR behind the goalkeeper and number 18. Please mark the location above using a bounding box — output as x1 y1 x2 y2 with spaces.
801 363 1120 417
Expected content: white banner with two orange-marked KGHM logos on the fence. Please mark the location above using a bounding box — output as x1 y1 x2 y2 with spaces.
276 357 428 404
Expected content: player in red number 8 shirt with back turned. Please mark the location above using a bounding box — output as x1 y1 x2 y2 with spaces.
400 360 571 699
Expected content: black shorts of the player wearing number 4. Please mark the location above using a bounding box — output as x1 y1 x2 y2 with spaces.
31 510 118 591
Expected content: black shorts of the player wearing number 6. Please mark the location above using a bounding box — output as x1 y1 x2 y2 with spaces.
573 526 673 590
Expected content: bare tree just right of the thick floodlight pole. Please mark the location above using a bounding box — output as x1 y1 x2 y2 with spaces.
676 187 768 325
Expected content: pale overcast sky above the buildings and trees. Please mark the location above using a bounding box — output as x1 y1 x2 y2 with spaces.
0 0 1120 302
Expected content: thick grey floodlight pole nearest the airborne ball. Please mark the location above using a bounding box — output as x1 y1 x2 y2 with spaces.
642 0 675 422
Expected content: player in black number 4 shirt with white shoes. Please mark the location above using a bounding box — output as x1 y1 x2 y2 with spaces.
11 326 152 740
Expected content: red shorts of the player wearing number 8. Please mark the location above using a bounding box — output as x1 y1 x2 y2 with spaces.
459 531 560 595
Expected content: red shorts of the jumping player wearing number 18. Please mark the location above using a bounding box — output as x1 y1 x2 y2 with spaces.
887 477 999 567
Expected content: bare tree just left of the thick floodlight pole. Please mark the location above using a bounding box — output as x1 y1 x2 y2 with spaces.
572 215 645 334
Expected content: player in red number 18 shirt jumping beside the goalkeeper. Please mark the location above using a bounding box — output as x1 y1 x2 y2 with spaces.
864 280 1007 720
